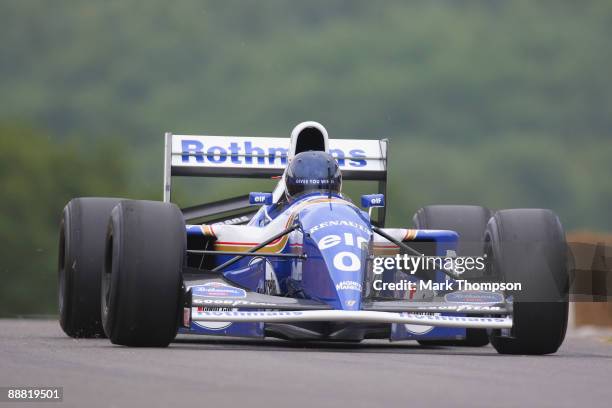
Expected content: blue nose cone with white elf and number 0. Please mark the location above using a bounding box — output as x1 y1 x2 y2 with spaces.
300 199 372 310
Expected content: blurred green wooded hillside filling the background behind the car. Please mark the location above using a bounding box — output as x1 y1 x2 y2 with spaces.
0 0 612 314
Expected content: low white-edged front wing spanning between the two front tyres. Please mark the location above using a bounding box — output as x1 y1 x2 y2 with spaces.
183 271 512 329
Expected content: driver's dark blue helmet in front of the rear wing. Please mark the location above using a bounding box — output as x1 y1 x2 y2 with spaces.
285 151 342 201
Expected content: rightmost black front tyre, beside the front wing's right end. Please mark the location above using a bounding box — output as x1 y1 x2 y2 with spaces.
485 209 569 354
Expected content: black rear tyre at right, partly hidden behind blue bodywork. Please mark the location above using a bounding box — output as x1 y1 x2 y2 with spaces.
413 205 491 347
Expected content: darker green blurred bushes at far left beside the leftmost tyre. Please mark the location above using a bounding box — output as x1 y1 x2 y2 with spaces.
0 125 133 315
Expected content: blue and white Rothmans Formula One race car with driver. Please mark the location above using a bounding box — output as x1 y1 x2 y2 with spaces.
58 122 569 354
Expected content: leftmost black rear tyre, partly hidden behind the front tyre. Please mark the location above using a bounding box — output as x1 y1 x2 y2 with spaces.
58 197 121 337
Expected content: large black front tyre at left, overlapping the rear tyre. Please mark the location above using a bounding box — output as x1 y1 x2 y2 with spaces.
101 201 186 347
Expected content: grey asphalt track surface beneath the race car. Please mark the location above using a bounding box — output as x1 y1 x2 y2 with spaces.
0 320 612 408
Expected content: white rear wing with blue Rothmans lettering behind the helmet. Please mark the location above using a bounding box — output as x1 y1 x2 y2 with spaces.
163 133 388 223
